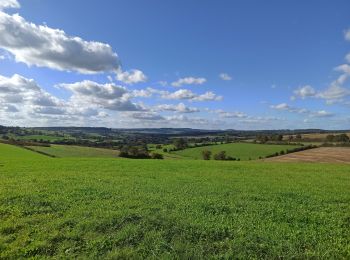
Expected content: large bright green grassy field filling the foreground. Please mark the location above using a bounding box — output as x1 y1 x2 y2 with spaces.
0 144 350 259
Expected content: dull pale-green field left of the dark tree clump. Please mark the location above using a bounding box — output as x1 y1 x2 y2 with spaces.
29 145 119 158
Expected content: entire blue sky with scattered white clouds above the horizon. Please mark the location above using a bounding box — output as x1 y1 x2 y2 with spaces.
0 0 350 130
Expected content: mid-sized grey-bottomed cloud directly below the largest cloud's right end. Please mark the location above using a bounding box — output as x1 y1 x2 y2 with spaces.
57 80 144 111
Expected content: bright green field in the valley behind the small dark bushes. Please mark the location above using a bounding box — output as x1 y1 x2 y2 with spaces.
171 143 298 160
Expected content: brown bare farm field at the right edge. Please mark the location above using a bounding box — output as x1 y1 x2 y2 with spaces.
265 147 350 163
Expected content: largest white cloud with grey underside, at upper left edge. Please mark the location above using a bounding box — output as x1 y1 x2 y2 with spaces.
0 11 120 74
